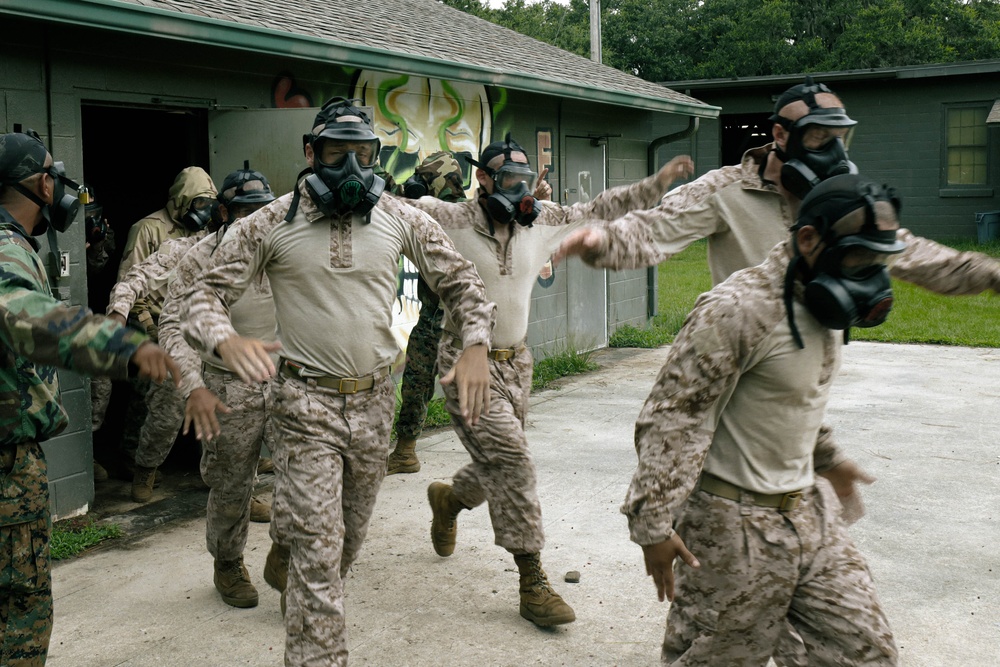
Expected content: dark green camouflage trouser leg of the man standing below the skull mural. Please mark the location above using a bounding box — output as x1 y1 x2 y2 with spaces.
396 280 444 440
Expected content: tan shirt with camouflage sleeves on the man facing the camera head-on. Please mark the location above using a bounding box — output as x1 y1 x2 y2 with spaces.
181 179 495 377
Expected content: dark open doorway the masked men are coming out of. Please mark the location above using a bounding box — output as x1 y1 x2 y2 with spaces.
81 102 210 475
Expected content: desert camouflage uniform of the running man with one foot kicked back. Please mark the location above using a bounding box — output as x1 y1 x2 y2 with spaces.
402 166 700 554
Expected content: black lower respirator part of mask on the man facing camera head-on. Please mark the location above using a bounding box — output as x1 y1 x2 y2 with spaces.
306 151 385 217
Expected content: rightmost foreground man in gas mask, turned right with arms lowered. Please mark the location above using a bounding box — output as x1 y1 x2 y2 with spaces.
622 174 905 667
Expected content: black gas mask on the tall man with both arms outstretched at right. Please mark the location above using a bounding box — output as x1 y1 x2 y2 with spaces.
765 77 858 199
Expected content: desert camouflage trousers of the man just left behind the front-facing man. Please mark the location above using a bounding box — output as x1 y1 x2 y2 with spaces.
201 370 271 560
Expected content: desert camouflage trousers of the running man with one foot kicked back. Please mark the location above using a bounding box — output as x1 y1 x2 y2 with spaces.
438 336 545 554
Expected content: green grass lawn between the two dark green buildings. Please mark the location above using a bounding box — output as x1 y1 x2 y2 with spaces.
611 240 1000 347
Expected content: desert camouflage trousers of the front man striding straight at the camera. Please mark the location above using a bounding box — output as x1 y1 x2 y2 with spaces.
271 375 396 667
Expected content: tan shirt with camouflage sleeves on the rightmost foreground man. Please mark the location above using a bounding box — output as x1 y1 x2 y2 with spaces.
621 243 843 545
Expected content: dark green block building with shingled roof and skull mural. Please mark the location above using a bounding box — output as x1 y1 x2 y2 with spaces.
0 0 719 517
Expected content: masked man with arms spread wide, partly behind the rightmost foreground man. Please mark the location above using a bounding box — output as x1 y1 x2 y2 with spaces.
557 77 1000 295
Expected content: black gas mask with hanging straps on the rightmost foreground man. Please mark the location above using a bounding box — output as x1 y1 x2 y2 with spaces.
785 174 906 347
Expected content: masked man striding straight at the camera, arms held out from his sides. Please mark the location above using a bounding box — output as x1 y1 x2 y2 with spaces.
181 98 495 665
